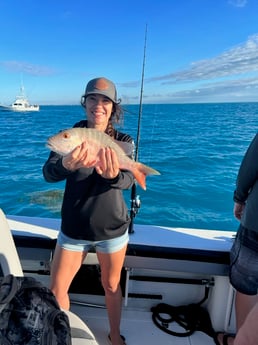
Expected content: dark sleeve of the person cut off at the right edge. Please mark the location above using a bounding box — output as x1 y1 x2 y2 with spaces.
233 134 258 204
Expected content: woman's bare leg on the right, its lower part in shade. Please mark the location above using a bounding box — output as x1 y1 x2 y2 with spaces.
97 245 127 345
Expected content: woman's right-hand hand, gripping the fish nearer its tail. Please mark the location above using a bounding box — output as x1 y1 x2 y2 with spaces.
95 147 120 179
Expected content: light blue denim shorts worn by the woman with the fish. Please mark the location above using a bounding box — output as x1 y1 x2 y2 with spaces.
57 231 129 253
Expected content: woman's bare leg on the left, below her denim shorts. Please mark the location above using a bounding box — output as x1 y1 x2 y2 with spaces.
50 244 87 310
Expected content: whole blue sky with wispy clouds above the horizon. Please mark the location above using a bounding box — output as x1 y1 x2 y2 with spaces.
0 0 258 105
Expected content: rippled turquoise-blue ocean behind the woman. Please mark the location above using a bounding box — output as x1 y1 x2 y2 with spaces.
0 103 258 231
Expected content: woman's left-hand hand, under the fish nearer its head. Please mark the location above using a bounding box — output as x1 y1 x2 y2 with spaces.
62 142 96 171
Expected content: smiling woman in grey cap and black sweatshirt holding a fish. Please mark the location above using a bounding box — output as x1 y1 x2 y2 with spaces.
43 77 134 345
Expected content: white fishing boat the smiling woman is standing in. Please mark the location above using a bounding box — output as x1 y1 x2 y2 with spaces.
0 208 238 345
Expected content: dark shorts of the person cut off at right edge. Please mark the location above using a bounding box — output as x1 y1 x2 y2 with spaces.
229 225 258 295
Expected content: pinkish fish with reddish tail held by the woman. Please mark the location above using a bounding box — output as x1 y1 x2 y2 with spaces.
46 127 160 190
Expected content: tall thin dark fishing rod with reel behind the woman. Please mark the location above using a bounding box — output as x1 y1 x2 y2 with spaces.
128 24 147 234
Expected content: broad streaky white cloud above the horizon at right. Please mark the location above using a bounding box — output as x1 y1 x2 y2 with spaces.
120 34 258 103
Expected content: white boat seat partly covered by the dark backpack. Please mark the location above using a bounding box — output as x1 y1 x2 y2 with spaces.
0 208 98 345
